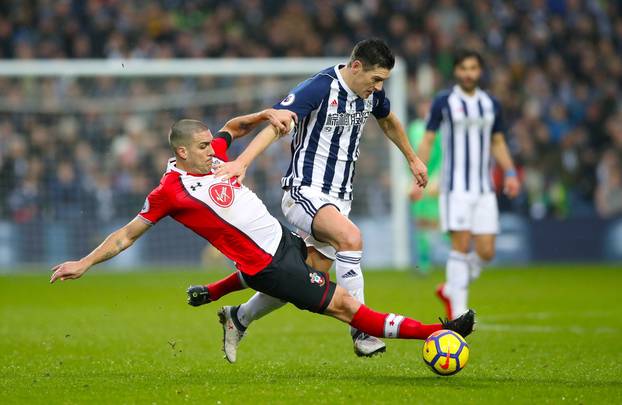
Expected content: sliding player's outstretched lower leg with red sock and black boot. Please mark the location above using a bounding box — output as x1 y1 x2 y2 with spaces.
324 286 475 339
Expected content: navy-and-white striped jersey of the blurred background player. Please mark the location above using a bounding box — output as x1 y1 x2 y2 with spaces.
426 85 505 194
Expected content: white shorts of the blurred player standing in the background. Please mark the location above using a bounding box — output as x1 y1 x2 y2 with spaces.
439 193 499 235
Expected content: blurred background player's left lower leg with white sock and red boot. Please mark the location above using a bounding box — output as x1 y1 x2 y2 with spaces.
436 231 471 319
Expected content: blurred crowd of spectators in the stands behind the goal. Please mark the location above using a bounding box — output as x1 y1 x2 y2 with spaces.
0 0 622 227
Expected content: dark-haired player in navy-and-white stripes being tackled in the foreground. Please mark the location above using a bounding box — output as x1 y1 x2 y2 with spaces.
217 39 427 356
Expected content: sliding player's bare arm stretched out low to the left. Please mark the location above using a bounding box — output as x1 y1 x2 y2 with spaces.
50 217 151 283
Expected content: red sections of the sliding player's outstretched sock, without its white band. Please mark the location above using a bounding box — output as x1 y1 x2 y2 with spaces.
350 305 443 339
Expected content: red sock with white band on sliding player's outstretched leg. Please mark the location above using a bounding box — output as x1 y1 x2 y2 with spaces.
350 305 443 339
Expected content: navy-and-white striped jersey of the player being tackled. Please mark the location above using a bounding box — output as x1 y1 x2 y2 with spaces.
274 65 390 200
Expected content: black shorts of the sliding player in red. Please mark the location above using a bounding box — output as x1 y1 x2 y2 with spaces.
243 227 337 313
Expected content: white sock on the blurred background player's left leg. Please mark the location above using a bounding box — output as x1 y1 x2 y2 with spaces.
443 250 469 318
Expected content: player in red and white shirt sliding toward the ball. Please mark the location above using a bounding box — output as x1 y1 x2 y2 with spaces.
50 111 474 362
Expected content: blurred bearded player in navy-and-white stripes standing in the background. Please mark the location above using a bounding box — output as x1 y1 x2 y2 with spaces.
419 50 520 318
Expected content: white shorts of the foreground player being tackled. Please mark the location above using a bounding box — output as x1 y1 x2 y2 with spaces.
281 186 352 260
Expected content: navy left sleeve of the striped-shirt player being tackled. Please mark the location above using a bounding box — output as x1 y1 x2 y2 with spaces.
273 74 332 120
